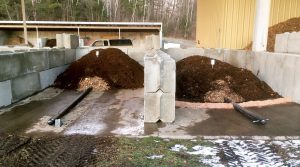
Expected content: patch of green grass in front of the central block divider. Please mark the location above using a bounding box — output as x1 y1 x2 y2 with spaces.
99 137 213 167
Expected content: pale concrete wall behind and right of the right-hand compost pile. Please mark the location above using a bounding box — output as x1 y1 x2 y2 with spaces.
164 48 300 103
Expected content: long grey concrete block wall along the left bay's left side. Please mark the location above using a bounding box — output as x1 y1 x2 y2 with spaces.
0 49 76 107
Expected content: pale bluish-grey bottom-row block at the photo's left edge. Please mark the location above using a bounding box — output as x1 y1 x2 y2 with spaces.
0 80 12 107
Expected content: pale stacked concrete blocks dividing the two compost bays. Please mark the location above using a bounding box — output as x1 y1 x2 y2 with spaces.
144 50 176 123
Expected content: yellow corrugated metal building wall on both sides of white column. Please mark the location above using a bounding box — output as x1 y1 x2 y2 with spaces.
196 0 300 49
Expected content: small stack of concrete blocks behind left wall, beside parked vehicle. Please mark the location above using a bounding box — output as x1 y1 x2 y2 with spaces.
56 33 79 49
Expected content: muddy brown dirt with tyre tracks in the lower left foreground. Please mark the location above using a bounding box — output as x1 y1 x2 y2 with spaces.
0 134 117 167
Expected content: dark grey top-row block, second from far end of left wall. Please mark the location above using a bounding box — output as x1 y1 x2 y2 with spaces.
48 49 65 68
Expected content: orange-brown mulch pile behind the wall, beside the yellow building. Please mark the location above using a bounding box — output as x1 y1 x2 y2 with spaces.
244 17 300 52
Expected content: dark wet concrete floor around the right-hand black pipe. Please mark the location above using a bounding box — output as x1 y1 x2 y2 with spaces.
187 103 300 136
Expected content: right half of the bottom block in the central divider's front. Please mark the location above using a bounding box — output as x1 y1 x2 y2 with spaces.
160 92 175 123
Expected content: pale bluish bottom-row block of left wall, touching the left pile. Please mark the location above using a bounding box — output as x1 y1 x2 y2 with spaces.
39 65 69 89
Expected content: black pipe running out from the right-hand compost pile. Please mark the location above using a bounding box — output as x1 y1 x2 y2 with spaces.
224 98 269 125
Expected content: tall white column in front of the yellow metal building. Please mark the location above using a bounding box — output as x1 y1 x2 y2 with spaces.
252 0 271 51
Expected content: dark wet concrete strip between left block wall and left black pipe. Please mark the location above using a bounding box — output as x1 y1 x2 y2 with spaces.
0 90 79 134
